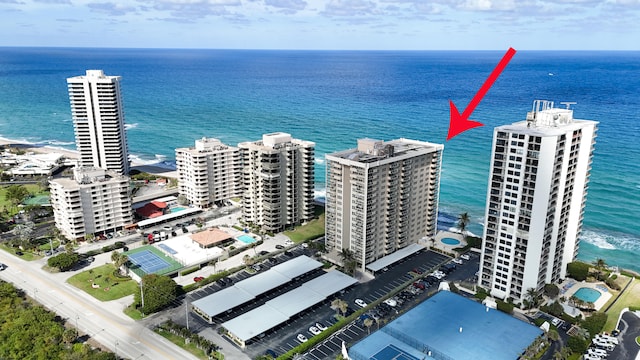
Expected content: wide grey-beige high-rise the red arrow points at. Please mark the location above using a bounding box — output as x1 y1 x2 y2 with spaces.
325 139 444 270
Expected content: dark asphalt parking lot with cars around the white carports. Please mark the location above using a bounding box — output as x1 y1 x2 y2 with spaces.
158 246 479 359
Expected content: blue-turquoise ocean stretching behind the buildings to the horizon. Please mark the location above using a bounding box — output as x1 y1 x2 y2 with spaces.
0 47 640 271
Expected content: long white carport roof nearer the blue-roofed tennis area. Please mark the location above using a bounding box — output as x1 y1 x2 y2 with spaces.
222 270 358 348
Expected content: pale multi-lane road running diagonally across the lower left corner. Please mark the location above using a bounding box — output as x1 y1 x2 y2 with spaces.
0 251 197 360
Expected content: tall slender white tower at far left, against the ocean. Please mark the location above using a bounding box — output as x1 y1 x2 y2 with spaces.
67 70 129 175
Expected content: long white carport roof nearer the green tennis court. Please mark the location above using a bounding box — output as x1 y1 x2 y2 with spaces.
191 255 322 323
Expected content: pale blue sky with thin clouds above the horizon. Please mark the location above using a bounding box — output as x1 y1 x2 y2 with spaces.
0 0 640 50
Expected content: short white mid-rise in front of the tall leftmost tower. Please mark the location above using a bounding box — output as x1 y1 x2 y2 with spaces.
49 167 133 239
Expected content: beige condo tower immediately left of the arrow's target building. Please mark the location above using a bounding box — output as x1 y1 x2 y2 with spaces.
238 132 315 232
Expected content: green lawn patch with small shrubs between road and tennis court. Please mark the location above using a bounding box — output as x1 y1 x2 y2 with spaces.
67 264 138 301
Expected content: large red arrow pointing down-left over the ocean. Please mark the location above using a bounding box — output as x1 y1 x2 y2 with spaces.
447 48 516 141
